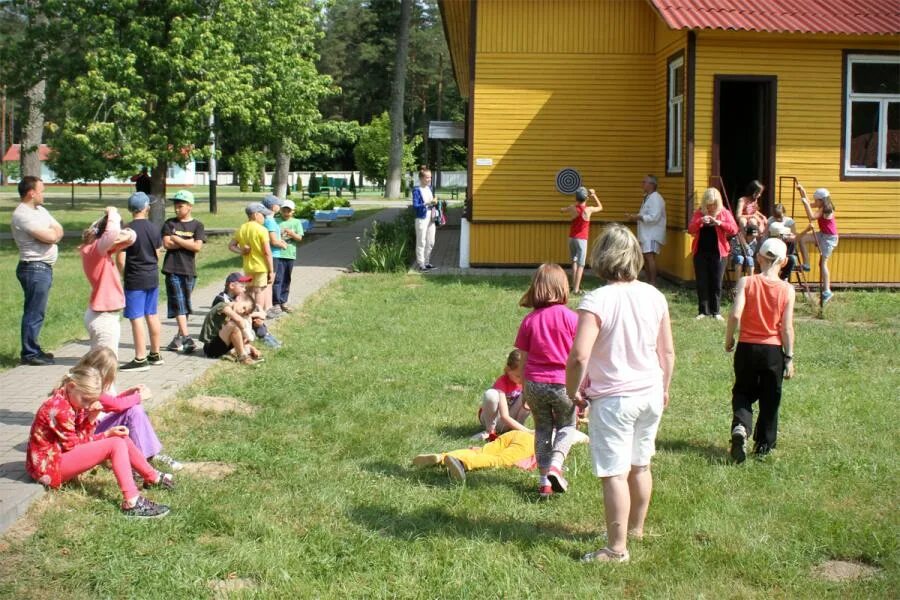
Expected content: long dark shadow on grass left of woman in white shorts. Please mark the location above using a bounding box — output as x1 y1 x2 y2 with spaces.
348 504 597 548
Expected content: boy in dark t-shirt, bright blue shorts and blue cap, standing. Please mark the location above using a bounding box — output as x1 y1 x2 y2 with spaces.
119 192 163 371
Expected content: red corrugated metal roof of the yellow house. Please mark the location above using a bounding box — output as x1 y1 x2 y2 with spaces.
650 0 900 35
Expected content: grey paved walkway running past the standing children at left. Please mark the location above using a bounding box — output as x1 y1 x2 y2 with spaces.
0 208 400 532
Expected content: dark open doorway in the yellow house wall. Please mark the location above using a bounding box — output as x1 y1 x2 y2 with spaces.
712 75 777 215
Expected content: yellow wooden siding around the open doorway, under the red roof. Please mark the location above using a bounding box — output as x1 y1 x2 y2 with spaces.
694 32 900 234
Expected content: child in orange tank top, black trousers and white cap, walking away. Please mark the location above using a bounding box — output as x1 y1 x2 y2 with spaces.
725 238 795 463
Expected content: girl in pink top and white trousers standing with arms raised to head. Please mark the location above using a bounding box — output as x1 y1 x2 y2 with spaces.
78 206 136 355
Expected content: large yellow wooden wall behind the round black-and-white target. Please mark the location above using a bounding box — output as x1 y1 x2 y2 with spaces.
470 0 665 229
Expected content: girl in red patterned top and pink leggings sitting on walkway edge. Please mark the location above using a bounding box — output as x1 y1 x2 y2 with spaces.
25 365 175 517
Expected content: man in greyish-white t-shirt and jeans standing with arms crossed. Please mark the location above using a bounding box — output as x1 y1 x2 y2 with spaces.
11 175 63 366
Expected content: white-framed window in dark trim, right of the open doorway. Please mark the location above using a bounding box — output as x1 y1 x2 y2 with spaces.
844 54 900 177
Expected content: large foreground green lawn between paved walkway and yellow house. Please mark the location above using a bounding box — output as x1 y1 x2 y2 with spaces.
0 275 900 599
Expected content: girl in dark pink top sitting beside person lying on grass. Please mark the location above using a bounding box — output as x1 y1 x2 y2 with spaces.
472 350 531 440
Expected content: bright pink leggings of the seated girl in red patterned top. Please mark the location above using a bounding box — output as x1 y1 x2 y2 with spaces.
59 437 159 500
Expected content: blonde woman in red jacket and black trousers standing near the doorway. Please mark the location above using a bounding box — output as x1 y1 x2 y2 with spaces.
688 188 738 321
